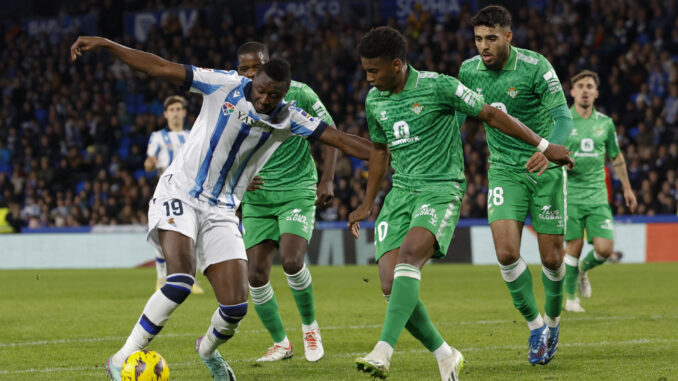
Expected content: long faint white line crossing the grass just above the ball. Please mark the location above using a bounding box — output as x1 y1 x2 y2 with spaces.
0 315 675 348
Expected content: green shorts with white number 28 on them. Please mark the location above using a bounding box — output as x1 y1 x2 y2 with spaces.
487 167 565 235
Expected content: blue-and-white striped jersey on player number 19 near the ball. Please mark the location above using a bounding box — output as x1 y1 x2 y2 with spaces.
165 65 328 209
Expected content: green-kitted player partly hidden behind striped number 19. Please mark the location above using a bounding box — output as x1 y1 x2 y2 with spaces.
238 42 336 362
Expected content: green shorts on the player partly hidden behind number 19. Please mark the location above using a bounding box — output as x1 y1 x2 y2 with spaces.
242 190 315 249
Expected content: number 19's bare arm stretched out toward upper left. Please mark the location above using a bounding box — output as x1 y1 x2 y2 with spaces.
71 36 186 85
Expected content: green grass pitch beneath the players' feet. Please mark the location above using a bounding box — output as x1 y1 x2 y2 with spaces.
0 263 678 381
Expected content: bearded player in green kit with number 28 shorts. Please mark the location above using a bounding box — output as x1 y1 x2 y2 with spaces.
459 6 572 364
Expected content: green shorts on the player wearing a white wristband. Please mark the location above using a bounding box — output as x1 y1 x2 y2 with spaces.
374 184 465 262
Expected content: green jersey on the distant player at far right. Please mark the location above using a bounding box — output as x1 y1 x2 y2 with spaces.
566 106 620 205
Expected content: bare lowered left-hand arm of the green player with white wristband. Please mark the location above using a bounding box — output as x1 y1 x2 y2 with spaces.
348 142 389 238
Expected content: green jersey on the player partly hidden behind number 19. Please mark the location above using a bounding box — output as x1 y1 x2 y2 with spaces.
243 81 334 197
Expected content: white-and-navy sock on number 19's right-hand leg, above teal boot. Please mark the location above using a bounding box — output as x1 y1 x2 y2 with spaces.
198 302 247 358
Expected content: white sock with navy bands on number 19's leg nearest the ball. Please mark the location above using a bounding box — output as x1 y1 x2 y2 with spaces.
111 274 195 367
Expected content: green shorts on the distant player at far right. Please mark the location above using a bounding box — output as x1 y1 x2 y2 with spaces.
565 204 614 243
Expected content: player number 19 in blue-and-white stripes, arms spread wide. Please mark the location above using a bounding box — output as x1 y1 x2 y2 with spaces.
71 37 370 381
